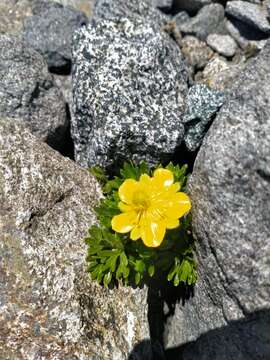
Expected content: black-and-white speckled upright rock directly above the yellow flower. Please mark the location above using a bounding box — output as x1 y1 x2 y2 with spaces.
72 17 187 166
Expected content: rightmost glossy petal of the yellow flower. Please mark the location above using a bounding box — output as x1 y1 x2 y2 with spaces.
165 192 191 219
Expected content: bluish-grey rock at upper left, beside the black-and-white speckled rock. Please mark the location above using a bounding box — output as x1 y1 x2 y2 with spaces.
23 0 88 74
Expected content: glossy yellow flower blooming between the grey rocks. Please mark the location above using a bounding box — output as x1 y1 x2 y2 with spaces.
111 168 191 247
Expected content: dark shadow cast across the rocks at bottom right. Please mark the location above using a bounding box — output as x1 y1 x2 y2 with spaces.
128 309 270 360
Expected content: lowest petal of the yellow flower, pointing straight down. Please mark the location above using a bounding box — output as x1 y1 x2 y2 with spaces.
141 221 166 247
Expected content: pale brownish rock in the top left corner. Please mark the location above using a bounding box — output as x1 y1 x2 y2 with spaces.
0 0 32 35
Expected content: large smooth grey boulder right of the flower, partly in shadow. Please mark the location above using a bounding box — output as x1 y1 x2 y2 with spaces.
168 42 270 360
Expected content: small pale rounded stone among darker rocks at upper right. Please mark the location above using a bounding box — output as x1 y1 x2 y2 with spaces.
206 34 237 57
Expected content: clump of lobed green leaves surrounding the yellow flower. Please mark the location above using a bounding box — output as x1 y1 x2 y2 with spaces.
85 162 197 287
